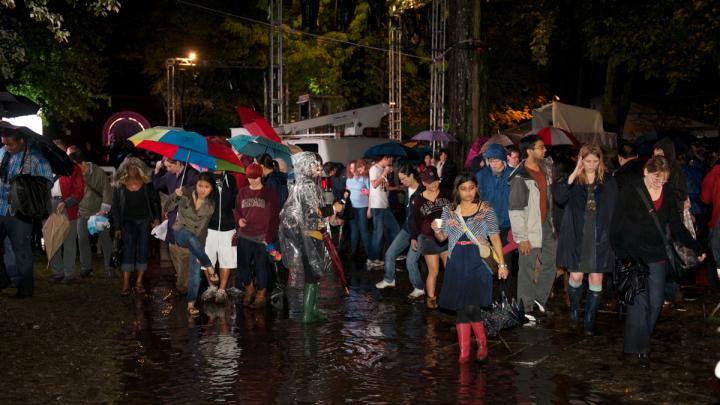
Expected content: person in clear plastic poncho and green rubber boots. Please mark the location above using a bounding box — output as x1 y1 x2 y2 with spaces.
278 152 342 322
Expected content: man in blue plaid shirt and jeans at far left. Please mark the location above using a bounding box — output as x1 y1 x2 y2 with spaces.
0 127 53 298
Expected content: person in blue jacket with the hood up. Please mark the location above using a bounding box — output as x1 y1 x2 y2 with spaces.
475 144 515 297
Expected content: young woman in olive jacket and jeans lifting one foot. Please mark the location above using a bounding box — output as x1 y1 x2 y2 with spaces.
166 172 218 316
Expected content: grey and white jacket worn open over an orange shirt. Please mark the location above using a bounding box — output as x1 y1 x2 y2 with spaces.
508 161 554 248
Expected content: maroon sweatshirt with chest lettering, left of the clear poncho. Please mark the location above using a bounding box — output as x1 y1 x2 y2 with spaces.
235 186 280 243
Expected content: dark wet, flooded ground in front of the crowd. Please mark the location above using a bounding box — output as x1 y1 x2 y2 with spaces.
0 254 720 404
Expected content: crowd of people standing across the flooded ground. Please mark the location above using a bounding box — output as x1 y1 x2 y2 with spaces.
0 127 720 363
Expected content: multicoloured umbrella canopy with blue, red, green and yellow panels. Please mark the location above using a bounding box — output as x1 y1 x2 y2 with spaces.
128 127 244 173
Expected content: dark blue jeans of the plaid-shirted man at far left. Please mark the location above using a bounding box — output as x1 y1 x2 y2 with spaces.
0 215 35 295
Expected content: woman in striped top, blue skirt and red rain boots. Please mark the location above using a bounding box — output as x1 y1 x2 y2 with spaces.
432 172 508 364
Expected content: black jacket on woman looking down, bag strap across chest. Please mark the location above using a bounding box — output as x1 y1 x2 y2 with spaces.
610 180 702 263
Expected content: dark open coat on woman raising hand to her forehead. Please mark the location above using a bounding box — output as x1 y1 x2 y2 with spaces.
554 176 617 273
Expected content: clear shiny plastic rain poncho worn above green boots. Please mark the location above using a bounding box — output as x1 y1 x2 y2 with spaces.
278 152 332 285
